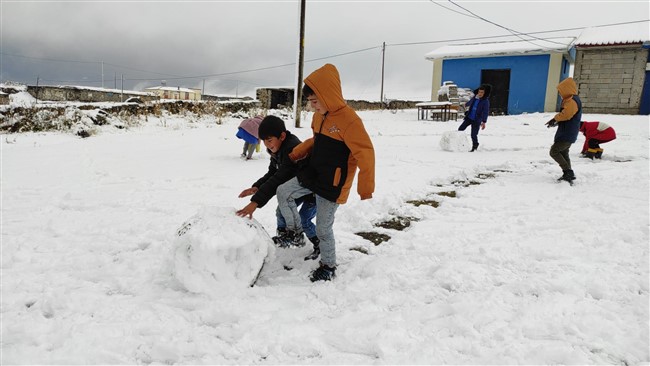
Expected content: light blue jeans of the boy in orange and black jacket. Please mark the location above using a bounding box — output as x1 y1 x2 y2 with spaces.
276 178 339 267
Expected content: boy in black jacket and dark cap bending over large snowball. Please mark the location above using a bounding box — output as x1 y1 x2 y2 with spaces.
236 116 320 259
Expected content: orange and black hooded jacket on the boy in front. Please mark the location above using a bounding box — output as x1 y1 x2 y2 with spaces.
289 64 375 204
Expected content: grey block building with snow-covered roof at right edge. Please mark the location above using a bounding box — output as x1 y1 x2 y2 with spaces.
574 22 650 114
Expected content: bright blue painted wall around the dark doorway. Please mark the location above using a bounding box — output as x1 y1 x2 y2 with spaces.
442 55 548 114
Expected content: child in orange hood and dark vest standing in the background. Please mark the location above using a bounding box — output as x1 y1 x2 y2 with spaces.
546 78 582 182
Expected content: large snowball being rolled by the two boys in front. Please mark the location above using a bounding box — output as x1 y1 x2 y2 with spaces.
174 207 274 294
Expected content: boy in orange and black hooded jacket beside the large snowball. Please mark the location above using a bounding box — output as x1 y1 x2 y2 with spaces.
277 64 375 282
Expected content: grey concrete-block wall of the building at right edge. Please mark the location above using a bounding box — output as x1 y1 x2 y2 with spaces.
574 45 648 114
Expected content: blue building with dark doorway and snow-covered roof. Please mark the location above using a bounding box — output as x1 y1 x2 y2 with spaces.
425 38 574 114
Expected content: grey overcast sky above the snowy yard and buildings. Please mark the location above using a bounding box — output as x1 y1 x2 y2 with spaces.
0 0 650 100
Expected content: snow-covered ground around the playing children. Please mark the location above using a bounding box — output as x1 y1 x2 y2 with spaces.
0 110 650 365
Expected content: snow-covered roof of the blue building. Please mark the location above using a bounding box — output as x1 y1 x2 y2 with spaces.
424 37 574 60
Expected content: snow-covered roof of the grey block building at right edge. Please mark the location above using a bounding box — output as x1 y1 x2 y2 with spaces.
575 22 650 46
